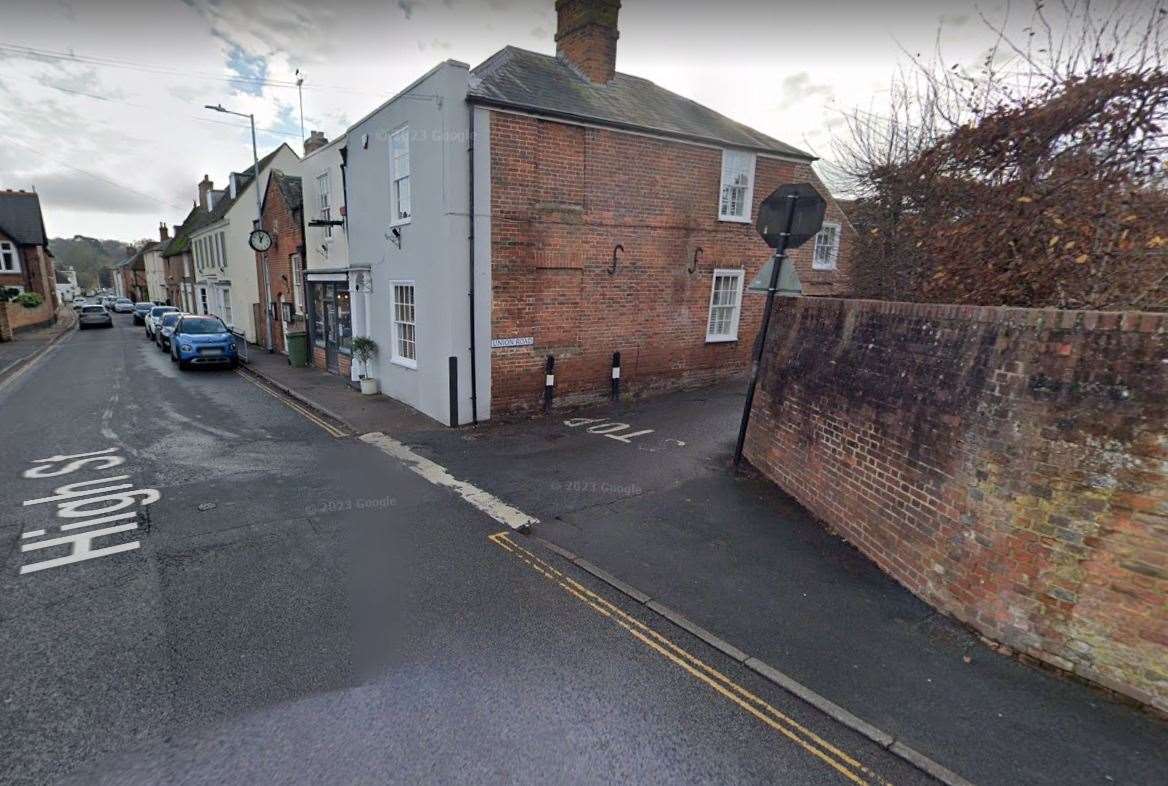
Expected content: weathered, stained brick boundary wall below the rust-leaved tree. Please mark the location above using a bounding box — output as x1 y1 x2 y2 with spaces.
746 298 1168 710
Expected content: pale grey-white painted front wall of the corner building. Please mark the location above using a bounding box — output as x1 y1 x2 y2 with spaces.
346 61 491 423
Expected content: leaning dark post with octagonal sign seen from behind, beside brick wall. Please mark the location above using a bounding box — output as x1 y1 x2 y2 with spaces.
734 183 827 469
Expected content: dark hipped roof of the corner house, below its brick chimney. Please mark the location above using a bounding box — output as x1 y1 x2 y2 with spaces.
470 47 815 161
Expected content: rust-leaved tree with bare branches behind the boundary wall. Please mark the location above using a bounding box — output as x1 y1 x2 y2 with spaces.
836 1 1168 309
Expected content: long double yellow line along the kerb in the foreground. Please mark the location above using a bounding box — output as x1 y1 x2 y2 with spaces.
488 531 891 786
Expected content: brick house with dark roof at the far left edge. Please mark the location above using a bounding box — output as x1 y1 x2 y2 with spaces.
0 190 57 331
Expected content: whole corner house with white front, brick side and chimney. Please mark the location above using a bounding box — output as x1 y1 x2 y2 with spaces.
346 0 853 423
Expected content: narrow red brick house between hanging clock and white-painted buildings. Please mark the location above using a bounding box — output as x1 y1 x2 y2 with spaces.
256 169 304 354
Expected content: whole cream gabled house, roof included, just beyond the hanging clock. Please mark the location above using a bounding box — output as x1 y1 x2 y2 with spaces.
190 144 300 342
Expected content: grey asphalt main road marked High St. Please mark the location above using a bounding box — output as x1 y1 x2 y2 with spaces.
0 318 929 784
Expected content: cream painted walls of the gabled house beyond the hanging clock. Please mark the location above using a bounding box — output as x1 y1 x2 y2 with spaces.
190 145 300 342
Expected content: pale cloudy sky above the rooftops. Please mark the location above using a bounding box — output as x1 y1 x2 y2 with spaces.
0 0 1079 239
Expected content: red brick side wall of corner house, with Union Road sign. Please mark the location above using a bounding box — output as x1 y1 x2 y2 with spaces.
491 112 849 416
